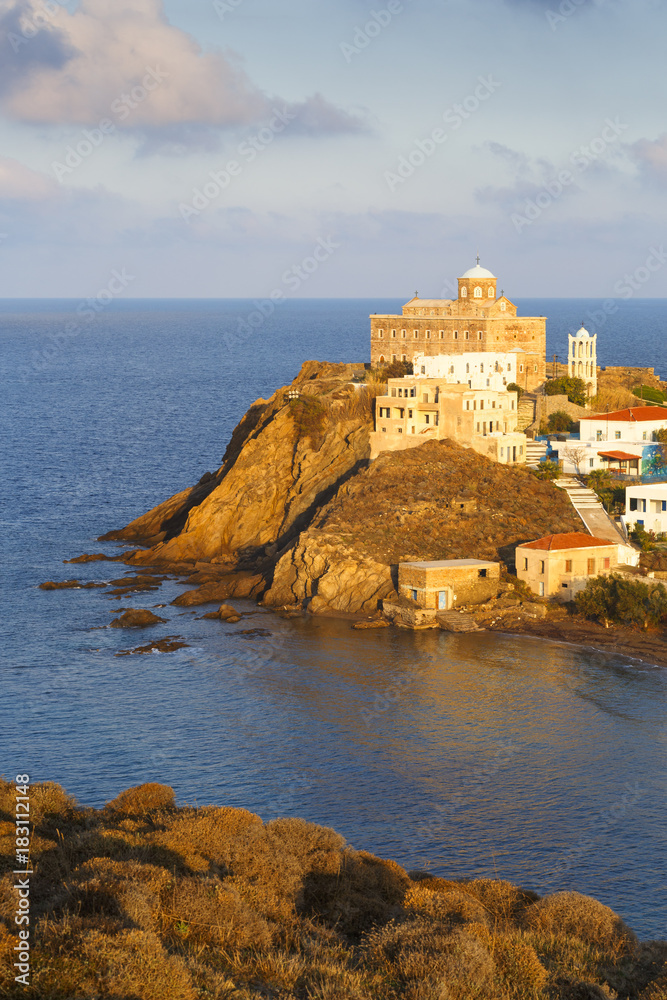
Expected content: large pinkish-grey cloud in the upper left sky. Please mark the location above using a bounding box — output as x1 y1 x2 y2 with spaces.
0 0 363 141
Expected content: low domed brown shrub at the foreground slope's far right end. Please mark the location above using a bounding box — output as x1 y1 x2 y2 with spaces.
523 892 636 953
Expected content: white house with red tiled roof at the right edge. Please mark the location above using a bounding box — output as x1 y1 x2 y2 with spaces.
553 406 667 476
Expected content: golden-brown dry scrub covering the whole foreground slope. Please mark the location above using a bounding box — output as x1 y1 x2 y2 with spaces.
0 781 667 1000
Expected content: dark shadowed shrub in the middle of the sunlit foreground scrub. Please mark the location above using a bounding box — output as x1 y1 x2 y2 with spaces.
304 849 411 937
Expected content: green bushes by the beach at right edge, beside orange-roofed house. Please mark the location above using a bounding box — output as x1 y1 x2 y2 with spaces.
575 573 667 628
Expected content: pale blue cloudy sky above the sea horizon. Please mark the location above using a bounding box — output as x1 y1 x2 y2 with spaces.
0 0 667 301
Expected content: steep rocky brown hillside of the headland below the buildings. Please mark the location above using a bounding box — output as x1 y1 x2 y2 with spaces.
98 362 580 614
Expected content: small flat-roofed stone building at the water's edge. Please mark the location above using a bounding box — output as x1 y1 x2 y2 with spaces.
398 559 500 612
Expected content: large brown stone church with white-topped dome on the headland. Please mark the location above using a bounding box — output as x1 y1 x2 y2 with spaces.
370 258 546 389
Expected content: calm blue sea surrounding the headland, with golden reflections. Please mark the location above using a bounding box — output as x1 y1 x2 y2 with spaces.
0 300 667 937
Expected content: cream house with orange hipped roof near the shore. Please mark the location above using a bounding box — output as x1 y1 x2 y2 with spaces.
515 532 622 601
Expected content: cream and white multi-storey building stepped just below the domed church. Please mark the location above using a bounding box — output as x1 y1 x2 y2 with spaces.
370 376 526 465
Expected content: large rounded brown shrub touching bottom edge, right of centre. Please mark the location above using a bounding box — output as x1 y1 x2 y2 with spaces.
366 918 495 1000
